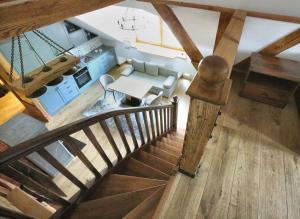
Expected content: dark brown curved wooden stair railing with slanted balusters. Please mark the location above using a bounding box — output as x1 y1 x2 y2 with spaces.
0 98 177 218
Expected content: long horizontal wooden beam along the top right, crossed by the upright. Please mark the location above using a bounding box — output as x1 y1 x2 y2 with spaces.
138 0 300 24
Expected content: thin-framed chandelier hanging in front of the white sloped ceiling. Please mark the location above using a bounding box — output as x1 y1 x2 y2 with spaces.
117 8 146 31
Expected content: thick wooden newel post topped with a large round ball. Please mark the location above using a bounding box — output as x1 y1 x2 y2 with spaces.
179 55 231 177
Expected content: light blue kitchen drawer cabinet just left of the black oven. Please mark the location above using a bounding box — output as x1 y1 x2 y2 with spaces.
57 76 79 103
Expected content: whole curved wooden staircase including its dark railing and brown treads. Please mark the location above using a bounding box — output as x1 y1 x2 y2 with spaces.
0 98 184 219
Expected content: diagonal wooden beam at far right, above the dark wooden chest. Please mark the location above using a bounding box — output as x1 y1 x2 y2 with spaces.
235 28 300 68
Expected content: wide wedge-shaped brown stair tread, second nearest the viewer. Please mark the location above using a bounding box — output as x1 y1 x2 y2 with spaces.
71 185 164 219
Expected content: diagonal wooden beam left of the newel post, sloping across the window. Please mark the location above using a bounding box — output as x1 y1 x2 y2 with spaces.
153 3 203 66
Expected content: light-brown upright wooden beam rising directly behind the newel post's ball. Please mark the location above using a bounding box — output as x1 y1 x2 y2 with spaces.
214 10 246 72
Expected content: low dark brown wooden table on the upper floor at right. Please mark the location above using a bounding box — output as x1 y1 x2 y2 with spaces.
240 53 300 108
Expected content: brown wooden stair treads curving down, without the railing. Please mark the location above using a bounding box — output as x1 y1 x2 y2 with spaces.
71 132 183 219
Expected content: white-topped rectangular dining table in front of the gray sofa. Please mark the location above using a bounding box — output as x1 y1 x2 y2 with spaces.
108 77 152 106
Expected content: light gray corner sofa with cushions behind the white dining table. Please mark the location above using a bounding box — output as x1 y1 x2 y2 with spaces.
121 59 182 97
